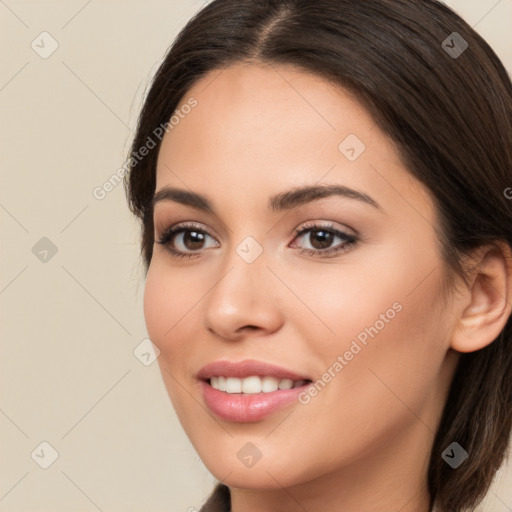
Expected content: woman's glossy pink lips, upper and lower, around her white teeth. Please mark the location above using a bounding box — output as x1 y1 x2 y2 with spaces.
197 359 312 423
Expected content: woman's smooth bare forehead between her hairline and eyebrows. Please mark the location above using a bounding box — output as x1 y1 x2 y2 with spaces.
156 63 428 224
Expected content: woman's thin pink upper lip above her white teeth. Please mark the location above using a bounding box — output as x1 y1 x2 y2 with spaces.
197 359 311 380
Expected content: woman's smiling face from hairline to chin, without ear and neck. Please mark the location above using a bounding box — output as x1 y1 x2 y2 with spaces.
144 64 460 489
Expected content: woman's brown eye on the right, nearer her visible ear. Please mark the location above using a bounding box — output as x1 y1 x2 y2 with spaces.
295 224 358 257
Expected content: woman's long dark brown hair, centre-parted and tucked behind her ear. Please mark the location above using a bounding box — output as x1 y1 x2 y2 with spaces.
125 0 512 512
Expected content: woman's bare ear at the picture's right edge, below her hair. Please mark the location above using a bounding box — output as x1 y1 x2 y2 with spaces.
450 241 512 352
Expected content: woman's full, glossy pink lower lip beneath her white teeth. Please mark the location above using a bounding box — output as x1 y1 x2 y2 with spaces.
200 381 311 423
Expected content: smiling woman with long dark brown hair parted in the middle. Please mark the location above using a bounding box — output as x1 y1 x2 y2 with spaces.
126 0 512 512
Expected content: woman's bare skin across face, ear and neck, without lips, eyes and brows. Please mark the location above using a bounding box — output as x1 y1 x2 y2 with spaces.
144 63 512 512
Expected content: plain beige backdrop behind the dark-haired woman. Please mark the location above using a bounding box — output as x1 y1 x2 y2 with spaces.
0 0 512 512
